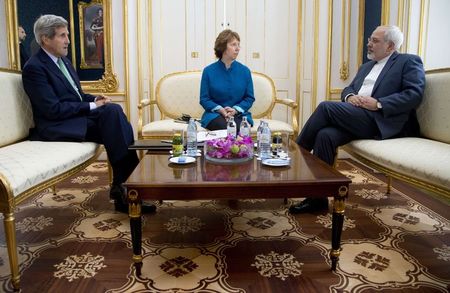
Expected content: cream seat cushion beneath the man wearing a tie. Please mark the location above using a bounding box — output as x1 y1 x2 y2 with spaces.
0 141 98 196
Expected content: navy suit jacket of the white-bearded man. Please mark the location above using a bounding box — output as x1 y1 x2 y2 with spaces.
341 52 425 139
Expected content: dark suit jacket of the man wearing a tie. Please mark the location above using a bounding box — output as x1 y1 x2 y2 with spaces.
22 49 95 141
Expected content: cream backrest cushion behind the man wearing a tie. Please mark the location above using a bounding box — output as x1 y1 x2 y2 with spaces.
0 70 33 146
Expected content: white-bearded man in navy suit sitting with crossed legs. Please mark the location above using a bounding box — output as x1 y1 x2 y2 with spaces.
289 26 425 213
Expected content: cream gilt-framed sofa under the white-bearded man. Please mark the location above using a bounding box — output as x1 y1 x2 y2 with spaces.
344 69 450 198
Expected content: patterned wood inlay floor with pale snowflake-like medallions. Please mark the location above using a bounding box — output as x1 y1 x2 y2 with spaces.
0 160 450 293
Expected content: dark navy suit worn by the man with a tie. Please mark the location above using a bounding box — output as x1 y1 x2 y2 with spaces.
22 49 138 184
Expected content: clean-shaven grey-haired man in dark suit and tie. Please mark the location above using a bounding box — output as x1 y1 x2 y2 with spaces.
22 15 155 212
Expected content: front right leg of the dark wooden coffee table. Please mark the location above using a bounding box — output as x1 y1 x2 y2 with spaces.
330 186 348 271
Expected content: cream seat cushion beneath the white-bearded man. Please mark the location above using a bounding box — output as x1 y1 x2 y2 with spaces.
348 137 450 189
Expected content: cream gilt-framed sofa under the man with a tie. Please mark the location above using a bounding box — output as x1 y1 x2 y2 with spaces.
0 70 101 289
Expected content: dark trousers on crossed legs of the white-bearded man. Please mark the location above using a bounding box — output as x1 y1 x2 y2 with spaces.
296 101 380 165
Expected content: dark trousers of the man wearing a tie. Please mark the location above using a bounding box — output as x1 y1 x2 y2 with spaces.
85 103 139 184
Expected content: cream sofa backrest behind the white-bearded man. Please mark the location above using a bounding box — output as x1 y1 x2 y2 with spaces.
417 70 450 143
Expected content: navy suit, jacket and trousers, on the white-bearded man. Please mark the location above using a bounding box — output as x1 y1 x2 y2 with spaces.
297 52 425 165
